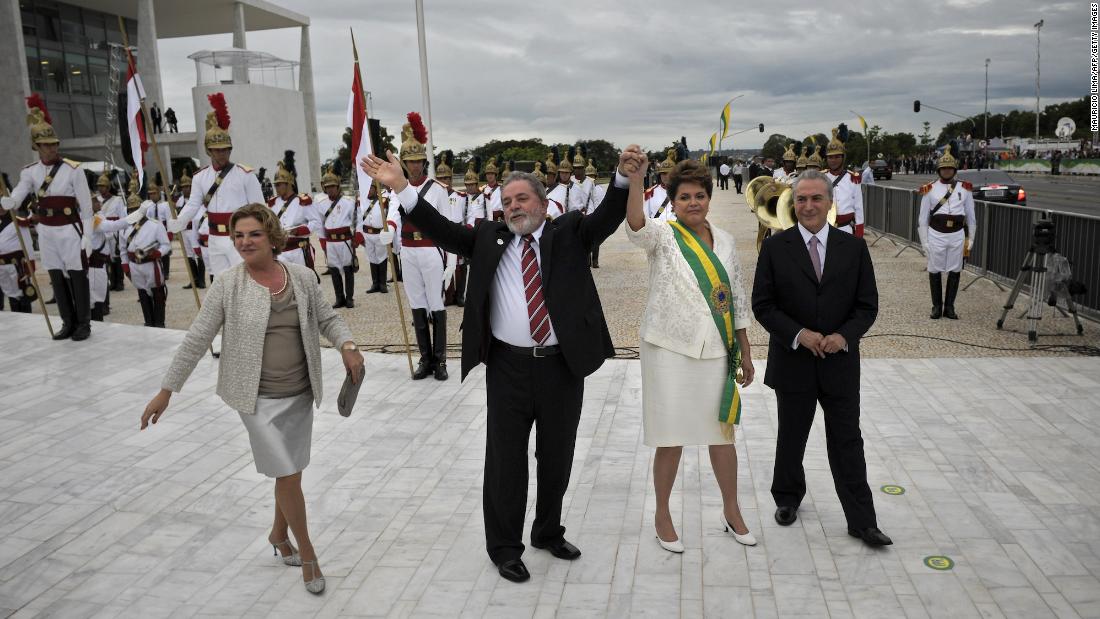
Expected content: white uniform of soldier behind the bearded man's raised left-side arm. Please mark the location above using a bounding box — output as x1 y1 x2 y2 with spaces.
389 179 453 312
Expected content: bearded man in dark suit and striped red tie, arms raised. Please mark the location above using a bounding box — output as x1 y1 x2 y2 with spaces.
361 145 645 583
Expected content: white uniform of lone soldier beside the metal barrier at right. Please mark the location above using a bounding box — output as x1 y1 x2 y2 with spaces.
917 179 978 273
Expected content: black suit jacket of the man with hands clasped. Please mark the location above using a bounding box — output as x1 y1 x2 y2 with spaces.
752 225 879 393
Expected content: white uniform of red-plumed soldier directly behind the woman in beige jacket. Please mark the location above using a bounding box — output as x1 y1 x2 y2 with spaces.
172 164 264 277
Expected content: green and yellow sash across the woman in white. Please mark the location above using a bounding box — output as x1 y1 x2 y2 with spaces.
669 221 741 438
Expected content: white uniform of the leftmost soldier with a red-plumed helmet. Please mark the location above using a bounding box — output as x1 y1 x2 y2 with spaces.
11 159 92 271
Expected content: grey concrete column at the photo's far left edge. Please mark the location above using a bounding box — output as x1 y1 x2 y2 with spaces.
0 0 32 177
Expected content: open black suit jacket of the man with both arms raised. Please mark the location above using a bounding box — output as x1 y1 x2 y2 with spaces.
406 180 628 379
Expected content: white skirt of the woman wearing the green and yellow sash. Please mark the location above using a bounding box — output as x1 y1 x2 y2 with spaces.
641 340 734 447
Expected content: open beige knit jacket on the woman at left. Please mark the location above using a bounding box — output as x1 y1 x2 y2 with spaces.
161 264 352 414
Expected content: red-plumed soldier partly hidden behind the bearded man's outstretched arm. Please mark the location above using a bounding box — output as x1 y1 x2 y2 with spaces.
391 112 451 380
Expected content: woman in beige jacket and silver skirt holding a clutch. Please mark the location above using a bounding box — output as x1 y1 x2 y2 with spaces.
141 205 363 594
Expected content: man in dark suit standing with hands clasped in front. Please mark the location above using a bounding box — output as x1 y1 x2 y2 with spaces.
752 170 892 545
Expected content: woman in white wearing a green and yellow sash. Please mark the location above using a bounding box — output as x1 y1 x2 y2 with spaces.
626 161 756 553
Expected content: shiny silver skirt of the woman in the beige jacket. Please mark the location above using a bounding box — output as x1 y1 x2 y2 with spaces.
239 389 314 477
